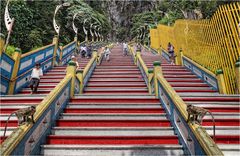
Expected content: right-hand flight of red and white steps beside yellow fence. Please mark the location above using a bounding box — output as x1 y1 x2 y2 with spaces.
142 47 240 155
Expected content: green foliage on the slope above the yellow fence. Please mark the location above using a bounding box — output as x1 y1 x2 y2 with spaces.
131 0 233 41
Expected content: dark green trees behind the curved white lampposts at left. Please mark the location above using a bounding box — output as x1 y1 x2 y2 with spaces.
0 0 110 53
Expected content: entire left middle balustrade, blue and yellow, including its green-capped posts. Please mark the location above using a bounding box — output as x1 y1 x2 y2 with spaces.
0 42 107 155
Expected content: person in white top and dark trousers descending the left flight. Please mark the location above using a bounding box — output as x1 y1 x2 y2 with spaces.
30 63 43 94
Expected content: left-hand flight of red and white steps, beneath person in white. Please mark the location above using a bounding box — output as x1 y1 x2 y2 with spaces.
0 58 89 143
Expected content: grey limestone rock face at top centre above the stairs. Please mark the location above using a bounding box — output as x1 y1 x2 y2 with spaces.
86 0 156 41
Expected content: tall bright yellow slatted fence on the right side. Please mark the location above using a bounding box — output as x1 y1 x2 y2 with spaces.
153 2 240 94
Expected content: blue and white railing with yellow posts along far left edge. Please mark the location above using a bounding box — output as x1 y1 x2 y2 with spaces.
0 37 77 94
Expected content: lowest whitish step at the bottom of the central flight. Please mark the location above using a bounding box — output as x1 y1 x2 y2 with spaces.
41 145 183 156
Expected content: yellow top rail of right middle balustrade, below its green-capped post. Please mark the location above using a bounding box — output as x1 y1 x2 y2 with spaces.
156 72 223 156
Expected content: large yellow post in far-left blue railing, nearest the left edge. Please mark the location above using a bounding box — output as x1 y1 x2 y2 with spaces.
8 49 22 94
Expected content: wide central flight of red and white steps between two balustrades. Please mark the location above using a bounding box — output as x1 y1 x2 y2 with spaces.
41 46 183 156
